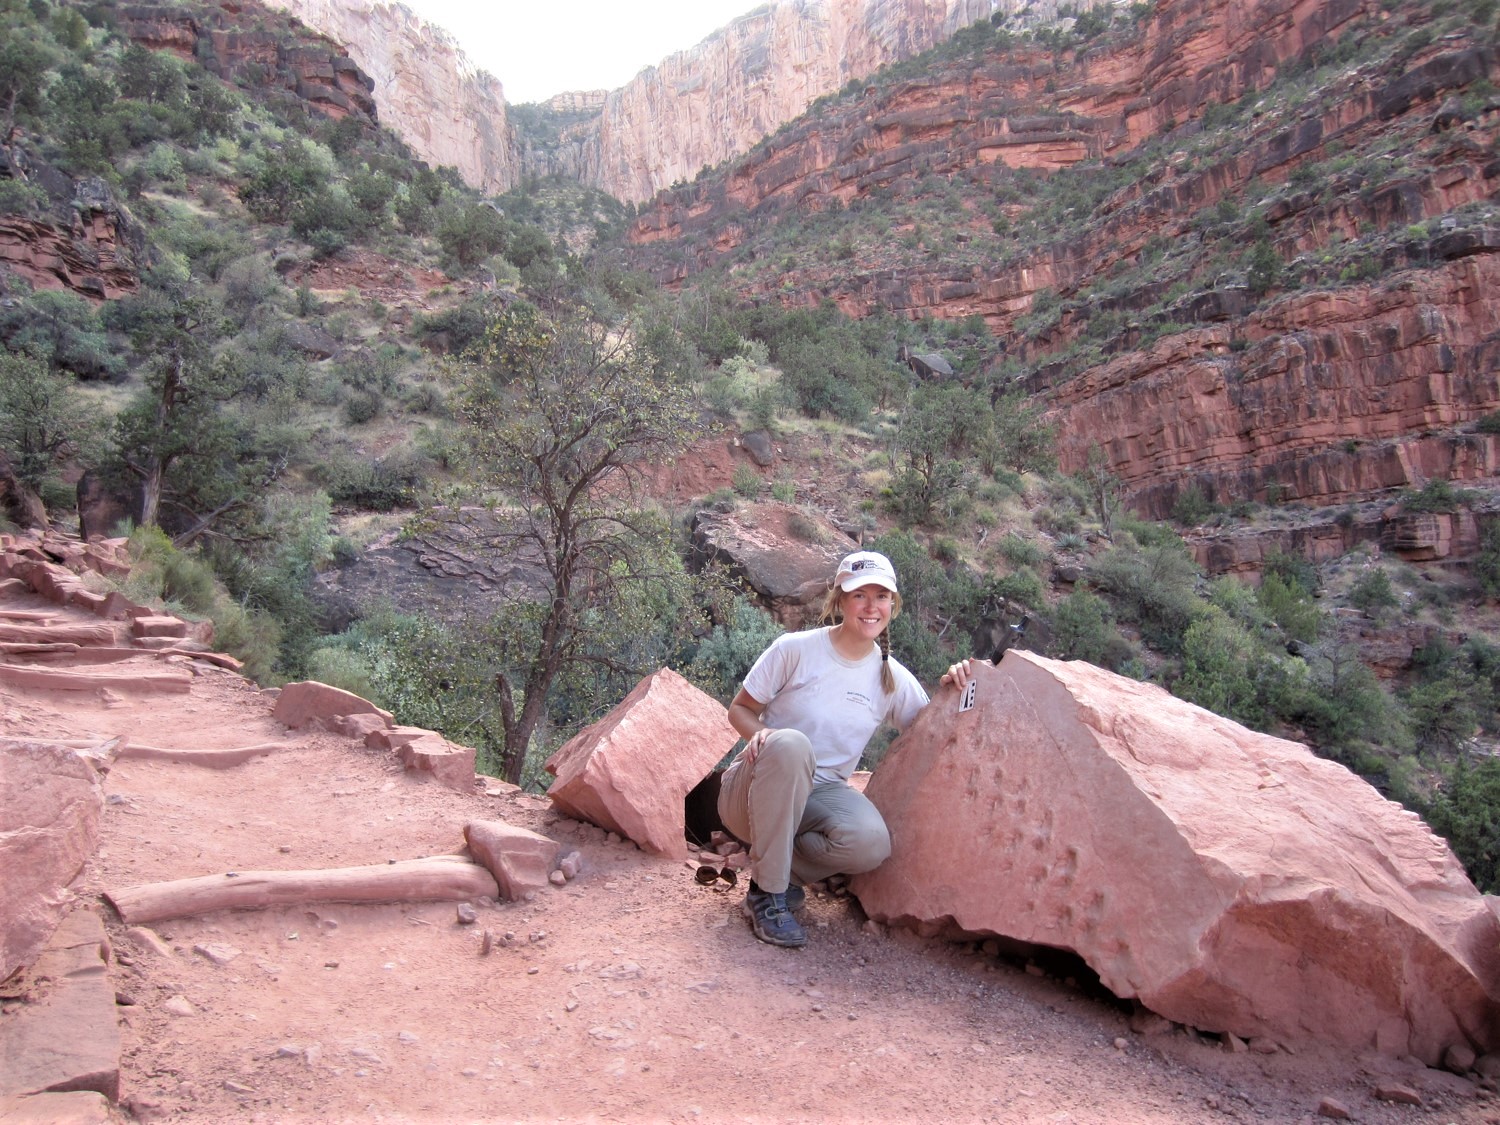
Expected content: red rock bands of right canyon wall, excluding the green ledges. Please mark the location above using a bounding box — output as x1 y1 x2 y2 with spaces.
632 0 1500 518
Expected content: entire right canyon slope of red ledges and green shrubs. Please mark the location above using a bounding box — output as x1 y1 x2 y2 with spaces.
630 0 1500 518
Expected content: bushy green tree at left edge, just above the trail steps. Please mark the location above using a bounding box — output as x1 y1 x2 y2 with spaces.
0 353 101 492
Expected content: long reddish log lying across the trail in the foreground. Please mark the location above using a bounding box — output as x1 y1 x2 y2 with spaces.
104 855 500 926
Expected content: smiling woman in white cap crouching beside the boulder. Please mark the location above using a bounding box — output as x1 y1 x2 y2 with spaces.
719 551 969 947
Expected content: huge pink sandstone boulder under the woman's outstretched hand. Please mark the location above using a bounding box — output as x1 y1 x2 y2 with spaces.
854 650 1500 1065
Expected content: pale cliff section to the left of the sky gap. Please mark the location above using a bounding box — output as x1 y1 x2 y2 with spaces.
259 0 518 192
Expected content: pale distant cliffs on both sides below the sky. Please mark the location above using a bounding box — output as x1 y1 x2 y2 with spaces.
258 0 1116 203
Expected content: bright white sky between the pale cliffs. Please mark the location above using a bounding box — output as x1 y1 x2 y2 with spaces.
402 0 761 105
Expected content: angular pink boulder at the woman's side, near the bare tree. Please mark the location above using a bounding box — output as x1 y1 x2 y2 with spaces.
546 669 737 855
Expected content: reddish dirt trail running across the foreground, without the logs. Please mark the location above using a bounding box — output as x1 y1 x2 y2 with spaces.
0 582 1500 1124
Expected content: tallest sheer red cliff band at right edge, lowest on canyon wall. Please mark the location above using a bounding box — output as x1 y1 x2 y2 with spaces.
1038 249 1500 518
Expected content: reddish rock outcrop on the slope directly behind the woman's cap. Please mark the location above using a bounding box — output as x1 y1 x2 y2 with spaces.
693 503 857 629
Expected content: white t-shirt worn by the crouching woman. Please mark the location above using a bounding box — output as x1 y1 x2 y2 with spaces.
746 626 927 782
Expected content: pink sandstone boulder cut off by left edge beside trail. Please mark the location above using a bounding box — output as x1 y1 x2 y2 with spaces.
0 738 104 981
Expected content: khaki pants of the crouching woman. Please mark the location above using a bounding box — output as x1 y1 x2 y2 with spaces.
719 729 891 894
